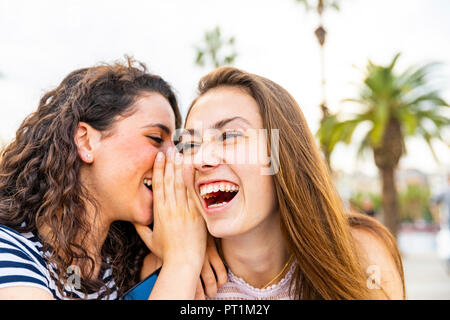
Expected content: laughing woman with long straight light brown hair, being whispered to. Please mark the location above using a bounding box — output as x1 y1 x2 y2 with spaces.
178 67 405 299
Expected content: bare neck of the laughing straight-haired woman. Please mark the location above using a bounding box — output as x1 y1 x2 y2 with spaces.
221 214 289 288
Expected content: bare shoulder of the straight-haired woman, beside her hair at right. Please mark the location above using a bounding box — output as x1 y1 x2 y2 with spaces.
352 227 404 299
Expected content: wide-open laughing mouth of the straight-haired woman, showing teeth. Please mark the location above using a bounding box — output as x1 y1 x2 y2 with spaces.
200 181 239 209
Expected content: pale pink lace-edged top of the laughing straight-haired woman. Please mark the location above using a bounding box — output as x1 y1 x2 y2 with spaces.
209 263 295 300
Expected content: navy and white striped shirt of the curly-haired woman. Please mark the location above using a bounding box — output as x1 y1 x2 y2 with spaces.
0 225 117 300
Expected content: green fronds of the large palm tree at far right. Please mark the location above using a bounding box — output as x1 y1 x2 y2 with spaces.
317 54 450 160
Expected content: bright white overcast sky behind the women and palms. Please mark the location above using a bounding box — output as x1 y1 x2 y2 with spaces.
0 0 450 174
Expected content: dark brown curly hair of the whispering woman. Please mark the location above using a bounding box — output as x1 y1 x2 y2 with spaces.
0 57 181 298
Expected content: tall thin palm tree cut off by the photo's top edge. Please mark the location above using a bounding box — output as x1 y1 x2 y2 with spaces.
295 0 339 170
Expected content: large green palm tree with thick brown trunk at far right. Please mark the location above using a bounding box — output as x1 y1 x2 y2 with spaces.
318 54 450 235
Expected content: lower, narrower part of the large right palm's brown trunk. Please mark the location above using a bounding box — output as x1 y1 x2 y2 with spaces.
379 167 398 237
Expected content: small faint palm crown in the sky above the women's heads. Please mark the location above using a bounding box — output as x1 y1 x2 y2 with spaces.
195 26 237 68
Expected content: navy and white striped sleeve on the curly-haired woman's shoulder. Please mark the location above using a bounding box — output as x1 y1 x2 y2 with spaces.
0 226 51 294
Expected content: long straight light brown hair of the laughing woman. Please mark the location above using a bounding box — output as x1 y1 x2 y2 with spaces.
187 67 404 299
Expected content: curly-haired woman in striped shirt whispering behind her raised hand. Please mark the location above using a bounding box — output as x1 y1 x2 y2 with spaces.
0 59 225 299
